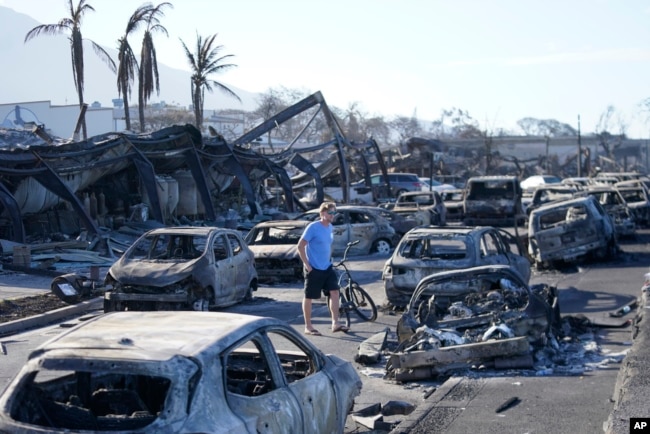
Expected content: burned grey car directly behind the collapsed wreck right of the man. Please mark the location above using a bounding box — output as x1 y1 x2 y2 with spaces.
382 226 531 307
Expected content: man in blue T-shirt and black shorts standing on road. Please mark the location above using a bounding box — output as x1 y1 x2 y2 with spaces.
298 202 348 336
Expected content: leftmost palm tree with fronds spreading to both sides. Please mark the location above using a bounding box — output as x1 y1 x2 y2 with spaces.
25 0 115 140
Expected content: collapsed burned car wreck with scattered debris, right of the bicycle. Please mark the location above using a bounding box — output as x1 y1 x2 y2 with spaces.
355 266 631 383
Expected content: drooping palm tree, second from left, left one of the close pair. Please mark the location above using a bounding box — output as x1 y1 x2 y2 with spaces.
117 4 152 130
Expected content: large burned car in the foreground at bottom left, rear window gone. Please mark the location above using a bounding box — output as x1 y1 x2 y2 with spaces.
0 312 362 433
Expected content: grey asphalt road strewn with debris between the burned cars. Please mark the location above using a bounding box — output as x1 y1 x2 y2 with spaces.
0 230 650 433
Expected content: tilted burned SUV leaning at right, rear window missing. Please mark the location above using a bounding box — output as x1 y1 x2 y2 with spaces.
528 196 618 268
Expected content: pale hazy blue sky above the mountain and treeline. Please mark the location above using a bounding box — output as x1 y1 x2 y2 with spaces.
0 0 650 138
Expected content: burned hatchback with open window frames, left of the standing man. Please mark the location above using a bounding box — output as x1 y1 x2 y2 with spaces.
104 226 257 312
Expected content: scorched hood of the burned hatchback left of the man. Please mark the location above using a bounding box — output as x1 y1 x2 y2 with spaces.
108 258 200 288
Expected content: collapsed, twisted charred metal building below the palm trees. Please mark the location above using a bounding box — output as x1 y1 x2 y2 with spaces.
0 92 386 256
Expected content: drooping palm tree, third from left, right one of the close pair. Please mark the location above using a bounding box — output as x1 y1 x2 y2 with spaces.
138 2 174 132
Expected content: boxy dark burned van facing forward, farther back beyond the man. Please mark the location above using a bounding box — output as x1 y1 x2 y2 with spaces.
463 176 525 226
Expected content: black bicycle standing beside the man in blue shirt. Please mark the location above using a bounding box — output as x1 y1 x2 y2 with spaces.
327 240 377 328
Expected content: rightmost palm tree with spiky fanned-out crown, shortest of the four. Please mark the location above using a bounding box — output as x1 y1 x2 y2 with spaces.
181 33 241 131
